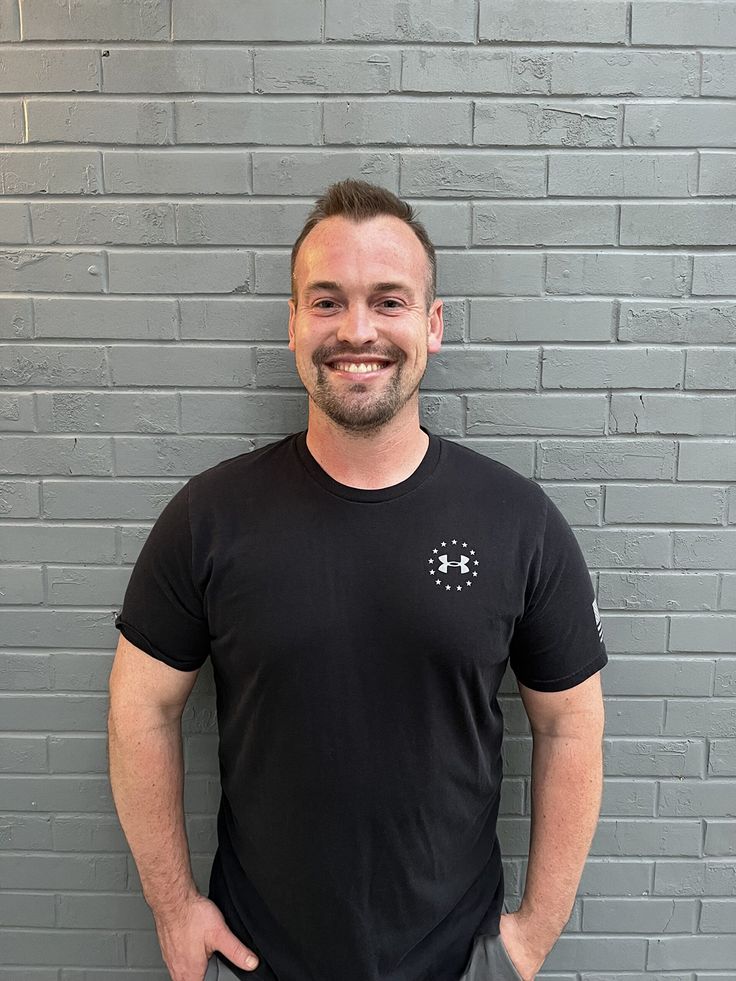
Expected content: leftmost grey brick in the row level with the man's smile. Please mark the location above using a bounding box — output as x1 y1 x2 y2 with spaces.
0 344 107 386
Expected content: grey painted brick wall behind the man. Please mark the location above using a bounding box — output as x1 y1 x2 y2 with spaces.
0 0 736 981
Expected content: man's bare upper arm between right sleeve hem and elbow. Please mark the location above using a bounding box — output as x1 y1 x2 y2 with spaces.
519 671 605 739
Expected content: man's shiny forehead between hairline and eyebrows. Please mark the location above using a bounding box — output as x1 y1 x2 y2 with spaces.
294 215 428 289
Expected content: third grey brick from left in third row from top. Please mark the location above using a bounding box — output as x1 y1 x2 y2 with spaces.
176 98 320 145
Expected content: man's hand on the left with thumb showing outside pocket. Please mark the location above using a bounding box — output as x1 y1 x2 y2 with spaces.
154 895 258 981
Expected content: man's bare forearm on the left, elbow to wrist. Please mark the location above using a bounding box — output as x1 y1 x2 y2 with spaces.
109 710 197 918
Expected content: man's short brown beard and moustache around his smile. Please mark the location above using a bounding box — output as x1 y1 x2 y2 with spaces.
309 346 421 434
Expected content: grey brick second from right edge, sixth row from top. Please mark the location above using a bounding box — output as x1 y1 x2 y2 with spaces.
547 252 697 296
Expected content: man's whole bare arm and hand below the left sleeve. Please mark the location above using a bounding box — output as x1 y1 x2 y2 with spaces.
108 636 254 981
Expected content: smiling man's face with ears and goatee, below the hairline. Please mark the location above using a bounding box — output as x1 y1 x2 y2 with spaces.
289 215 442 433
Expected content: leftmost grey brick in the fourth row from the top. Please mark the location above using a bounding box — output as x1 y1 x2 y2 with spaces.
0 147 102 195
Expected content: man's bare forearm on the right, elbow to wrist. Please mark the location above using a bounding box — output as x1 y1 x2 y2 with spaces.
519 733 603 956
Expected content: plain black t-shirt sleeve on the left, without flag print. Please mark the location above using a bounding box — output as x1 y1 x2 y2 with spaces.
115 484 210 671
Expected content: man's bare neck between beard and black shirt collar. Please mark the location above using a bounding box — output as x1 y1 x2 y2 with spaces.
307 400 429 490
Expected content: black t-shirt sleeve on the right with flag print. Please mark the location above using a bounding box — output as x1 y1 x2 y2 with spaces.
510 495 608 691
